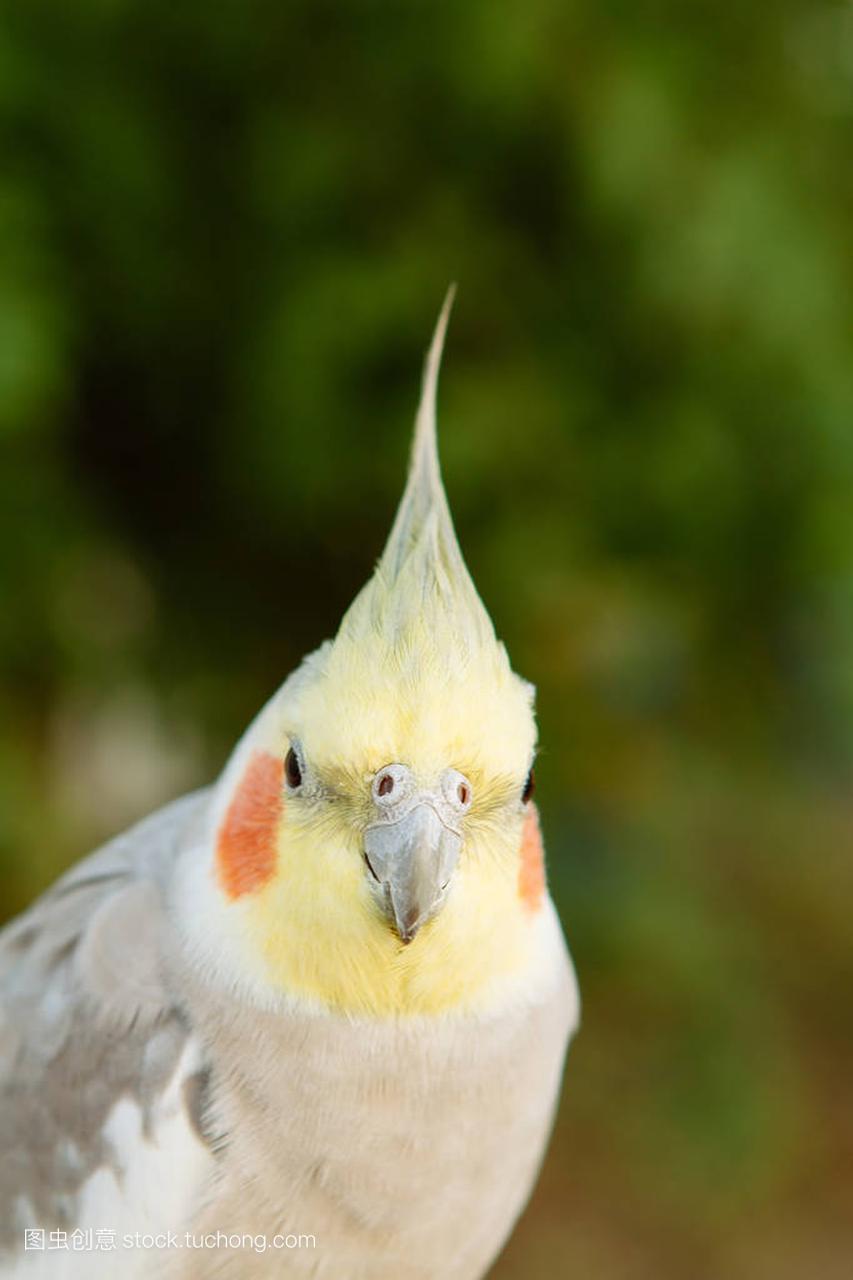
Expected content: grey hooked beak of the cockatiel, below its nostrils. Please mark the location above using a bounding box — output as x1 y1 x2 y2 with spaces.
364 800 462 942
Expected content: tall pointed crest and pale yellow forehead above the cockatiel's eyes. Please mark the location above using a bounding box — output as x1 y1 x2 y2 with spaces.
289 288 534 767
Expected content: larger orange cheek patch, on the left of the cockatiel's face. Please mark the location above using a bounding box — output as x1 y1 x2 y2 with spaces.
216 751 284 899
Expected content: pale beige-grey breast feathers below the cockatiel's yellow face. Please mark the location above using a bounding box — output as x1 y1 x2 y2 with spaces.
182 901 578 1280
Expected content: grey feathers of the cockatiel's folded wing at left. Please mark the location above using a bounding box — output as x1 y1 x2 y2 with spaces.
0 792 207 1248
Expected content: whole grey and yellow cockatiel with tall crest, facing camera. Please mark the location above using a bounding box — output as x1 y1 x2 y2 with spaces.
0 297 578 1280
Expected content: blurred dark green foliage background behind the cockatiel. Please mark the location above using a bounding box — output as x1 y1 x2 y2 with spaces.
0 0 853 1280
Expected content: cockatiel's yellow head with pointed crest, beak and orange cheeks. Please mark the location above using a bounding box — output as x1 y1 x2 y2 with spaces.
188 297 544 1014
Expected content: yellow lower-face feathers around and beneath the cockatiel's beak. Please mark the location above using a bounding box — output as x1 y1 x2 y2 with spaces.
247 783 532 1015
